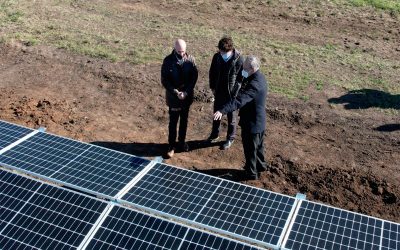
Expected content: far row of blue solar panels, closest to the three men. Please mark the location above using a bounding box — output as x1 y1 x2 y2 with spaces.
0 120 400 249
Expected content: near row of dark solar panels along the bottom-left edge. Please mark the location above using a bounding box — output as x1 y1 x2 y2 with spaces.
0 170 257 250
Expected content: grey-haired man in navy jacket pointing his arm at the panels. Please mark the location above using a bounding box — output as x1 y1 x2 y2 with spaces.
214 56 268 180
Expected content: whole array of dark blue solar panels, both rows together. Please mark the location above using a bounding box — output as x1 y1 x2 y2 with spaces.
0 121 400 249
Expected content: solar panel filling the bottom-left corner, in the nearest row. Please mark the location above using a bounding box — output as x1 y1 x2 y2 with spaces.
0 168 107 249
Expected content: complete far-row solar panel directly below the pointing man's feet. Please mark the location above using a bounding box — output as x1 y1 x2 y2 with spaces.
121 164 295 247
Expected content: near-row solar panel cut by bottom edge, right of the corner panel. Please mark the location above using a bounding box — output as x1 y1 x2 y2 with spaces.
87 206 257 250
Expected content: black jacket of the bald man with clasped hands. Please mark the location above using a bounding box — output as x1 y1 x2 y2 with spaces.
161 51 198 108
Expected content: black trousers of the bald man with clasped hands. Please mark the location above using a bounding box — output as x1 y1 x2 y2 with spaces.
168 107 189 147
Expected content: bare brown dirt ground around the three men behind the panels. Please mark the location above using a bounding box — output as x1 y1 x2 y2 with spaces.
0 1 400 225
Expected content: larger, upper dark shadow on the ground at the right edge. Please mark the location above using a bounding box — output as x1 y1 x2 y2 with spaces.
328 89 400 109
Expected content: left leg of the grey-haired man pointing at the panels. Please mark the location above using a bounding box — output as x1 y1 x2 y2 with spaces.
242 128 258 179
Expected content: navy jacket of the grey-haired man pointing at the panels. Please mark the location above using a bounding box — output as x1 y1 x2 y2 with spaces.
220 70 268 134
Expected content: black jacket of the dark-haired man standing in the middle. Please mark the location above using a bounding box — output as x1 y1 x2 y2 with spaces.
209 50 243 106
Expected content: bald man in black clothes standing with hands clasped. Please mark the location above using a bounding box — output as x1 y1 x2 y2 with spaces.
161 39 198 158
